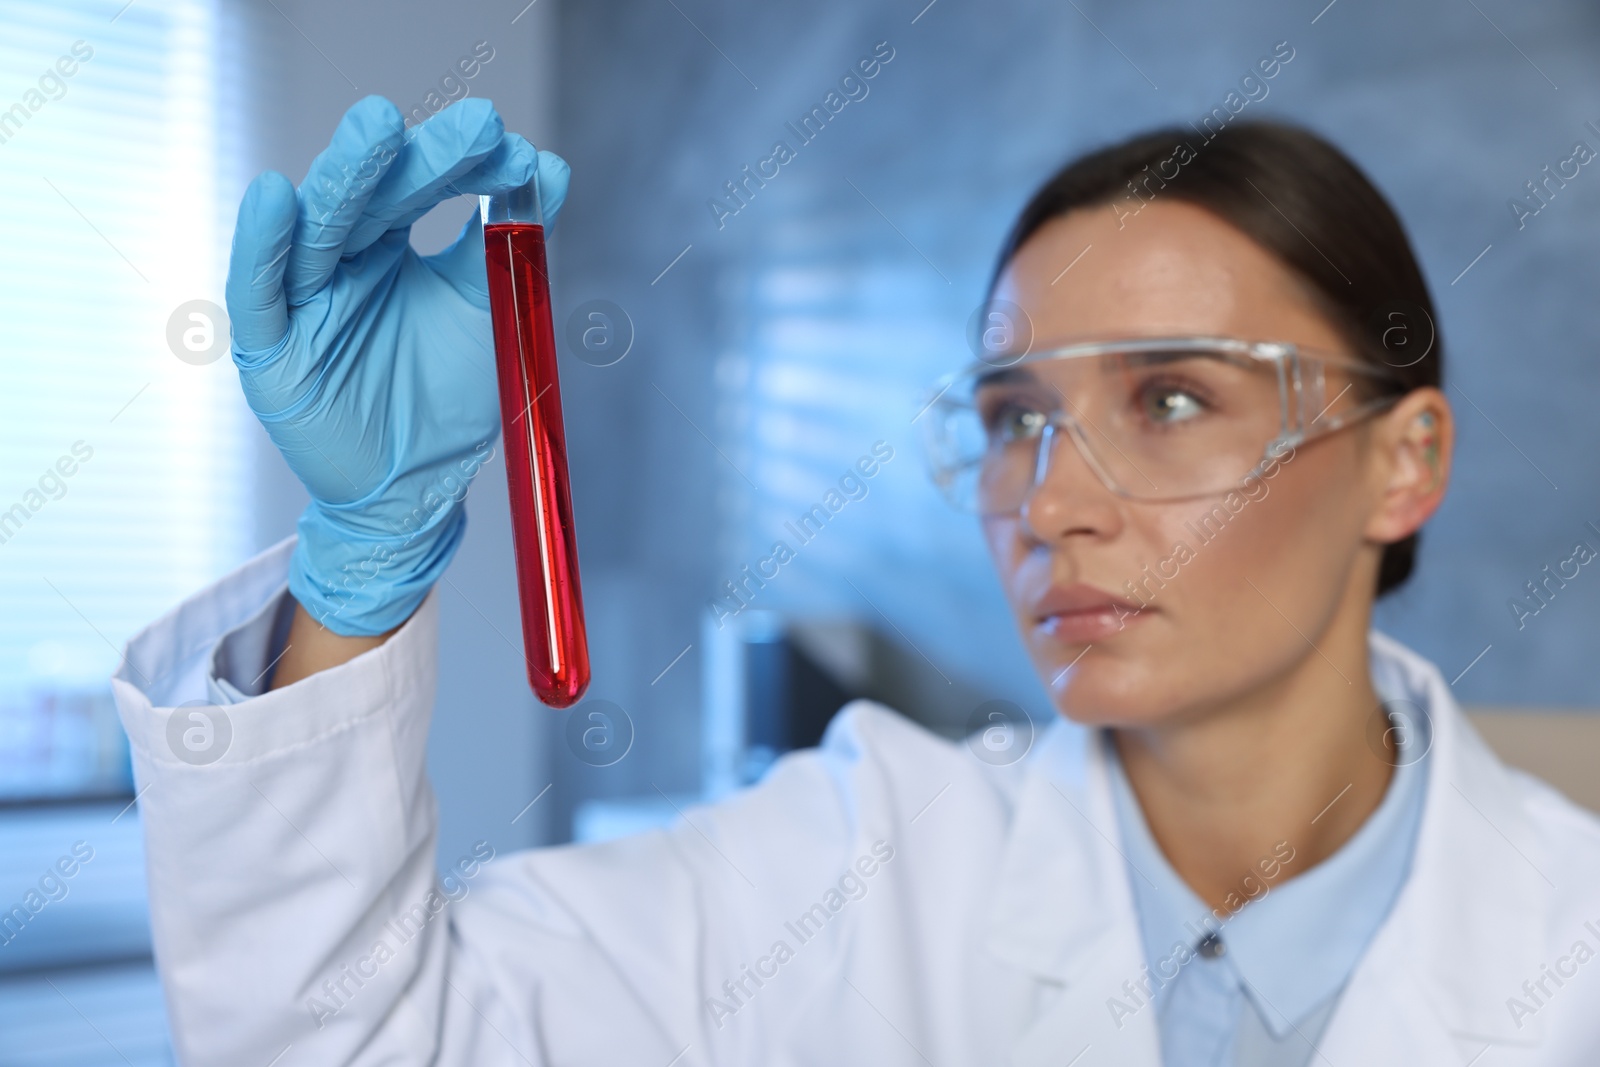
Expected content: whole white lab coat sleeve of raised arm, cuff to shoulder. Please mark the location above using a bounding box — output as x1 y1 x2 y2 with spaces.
114 542 886 1067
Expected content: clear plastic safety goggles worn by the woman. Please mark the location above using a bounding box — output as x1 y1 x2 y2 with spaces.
918 336 1398 515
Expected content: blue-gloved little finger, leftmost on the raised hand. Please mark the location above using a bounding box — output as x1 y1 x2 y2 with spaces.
226 171 298 357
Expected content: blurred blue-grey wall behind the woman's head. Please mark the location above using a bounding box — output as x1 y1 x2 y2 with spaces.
552 0 1600 809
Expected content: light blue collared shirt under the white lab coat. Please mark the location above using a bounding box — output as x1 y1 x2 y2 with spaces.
1099 702 1432 1067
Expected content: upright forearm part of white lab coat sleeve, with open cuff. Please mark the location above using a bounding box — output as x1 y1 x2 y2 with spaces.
114 542 446 1064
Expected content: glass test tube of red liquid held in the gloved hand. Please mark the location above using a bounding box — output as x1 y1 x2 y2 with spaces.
478 179 589 707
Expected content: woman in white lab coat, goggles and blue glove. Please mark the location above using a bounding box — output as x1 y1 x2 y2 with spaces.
117 98 1600 1067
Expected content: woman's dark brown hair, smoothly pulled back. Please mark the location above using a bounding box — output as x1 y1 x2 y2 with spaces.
989 120 1443 597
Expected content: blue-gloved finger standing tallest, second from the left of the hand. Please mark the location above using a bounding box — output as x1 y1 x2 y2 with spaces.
285 96 405 306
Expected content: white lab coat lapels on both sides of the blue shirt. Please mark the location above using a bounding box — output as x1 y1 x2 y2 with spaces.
987 632 1555 1064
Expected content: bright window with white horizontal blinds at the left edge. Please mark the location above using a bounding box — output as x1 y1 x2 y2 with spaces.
0 0 250 798
